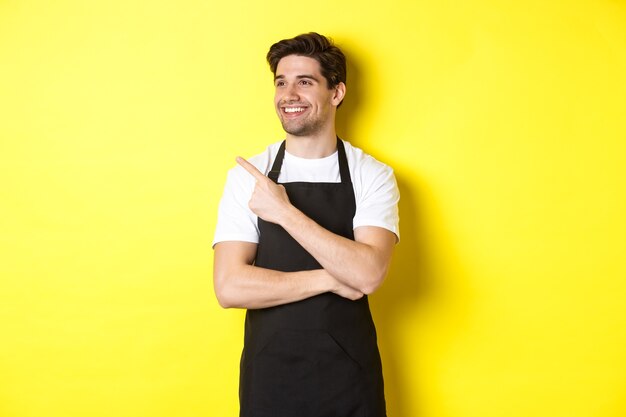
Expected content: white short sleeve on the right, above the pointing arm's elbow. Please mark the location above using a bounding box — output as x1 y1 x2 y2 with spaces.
353 159 400 240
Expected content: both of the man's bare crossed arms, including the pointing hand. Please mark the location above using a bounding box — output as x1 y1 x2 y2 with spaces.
213 158 396 309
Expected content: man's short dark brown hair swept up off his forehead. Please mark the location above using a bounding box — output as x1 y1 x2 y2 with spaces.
267 32 346 89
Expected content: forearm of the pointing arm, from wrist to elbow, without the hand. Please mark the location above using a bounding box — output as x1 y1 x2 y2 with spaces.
280 206 395 294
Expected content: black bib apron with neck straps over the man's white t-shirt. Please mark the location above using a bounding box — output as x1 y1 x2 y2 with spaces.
239 139 386 417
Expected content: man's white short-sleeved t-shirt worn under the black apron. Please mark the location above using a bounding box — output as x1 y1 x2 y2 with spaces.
213 141 400 245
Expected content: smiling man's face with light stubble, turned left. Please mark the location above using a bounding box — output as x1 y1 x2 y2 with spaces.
274 55 340 136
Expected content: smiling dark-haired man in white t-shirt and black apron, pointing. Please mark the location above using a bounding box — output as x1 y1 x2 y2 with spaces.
214 33 399 417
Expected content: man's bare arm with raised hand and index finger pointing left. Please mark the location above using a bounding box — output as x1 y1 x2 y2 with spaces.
237 158 396 294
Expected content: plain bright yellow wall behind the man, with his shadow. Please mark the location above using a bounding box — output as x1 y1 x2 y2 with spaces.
0 0 626 417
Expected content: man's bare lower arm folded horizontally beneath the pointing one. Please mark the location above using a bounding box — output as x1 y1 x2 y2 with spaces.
213 241 363 309
